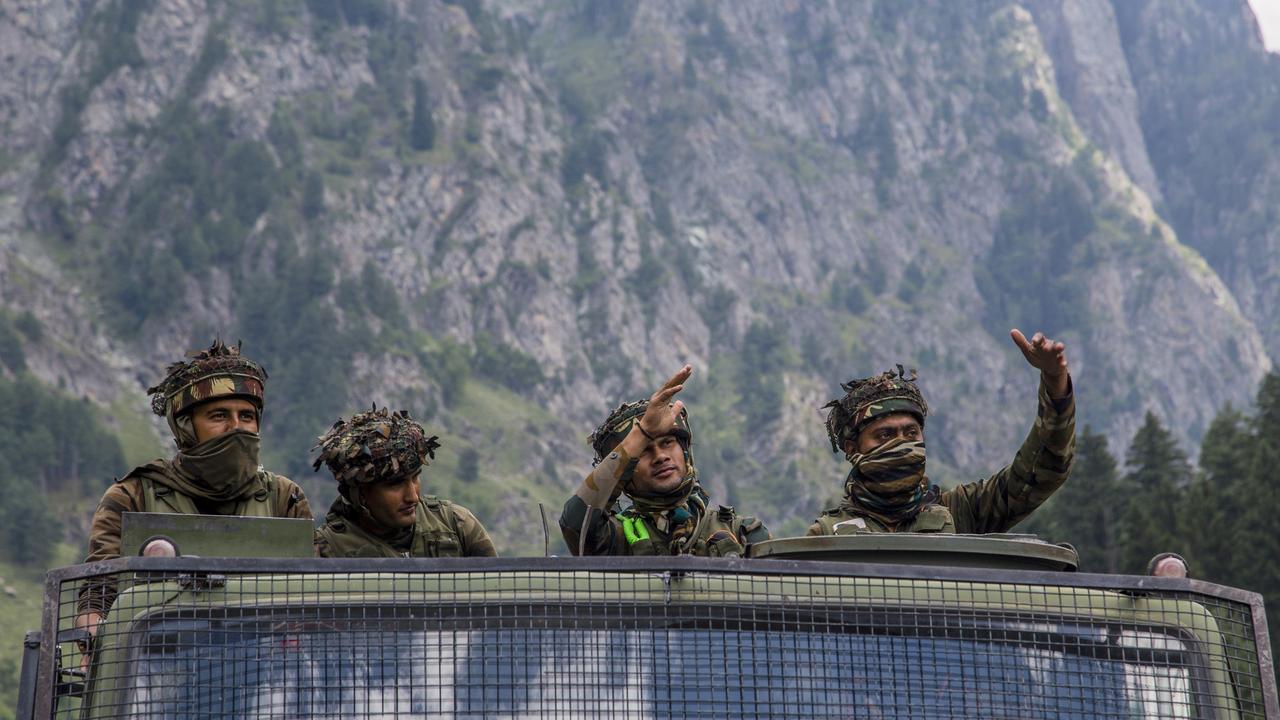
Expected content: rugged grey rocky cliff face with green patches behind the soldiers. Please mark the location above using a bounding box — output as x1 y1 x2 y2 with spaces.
0 0 1280 544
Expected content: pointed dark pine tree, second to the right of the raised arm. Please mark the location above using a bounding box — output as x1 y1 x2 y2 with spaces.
1120 411 1190 574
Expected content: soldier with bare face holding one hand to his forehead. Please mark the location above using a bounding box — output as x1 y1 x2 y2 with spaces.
559 365 769 557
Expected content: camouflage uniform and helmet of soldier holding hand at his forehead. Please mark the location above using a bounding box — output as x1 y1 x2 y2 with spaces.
559 401 769 557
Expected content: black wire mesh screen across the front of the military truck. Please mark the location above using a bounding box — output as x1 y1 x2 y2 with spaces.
44 559 1274 720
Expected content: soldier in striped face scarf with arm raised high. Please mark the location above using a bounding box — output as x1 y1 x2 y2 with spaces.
808 329 1075 536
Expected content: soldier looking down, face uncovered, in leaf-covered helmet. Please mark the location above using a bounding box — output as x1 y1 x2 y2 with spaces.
315 406 497 557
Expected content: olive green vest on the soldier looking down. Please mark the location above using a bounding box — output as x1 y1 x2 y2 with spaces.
316 495 465 557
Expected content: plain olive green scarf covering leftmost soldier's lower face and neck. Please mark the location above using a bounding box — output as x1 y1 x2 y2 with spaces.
165 430 259 502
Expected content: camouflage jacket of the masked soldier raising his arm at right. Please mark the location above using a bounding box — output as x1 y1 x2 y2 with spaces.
806 382 1075 536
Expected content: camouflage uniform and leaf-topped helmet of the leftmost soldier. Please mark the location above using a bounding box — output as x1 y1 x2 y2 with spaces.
81 341 311 612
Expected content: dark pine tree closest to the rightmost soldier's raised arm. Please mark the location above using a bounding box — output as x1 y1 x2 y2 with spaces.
1046 427 1123 573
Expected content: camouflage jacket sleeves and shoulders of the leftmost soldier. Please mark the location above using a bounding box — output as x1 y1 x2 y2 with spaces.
81 460 311 612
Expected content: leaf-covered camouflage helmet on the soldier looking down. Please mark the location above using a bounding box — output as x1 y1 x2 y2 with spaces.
311 405 440 487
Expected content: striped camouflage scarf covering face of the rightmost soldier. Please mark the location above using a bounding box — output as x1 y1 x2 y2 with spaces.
842 438 937 525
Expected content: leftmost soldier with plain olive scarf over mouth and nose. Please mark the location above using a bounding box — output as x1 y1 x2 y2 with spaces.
76 340 311 645
